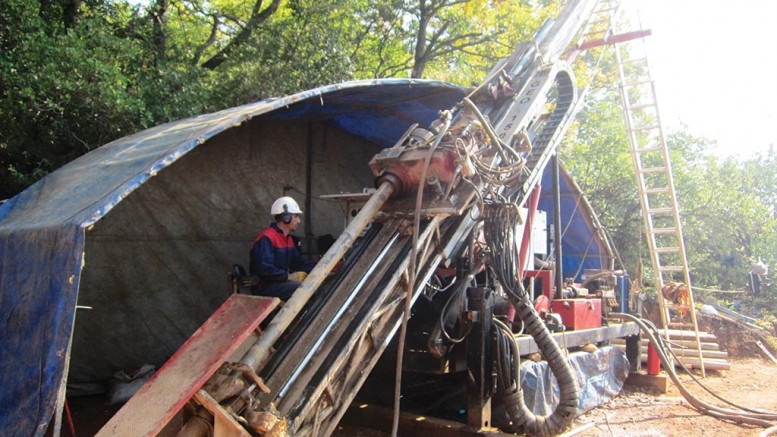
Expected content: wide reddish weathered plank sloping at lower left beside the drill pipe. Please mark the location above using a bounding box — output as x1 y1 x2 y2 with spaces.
97 294 280 437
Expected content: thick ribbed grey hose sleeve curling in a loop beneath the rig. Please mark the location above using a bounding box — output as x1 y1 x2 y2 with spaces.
503 293 580 436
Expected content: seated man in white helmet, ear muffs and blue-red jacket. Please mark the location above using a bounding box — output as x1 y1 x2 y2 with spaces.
249 196 312 301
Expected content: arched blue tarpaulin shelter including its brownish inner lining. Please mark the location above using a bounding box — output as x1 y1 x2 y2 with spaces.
0 79 616 436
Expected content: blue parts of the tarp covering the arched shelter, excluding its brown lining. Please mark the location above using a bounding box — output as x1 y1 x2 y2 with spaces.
0 79 616 436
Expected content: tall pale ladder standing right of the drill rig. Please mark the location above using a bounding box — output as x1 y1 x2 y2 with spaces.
615 32 705 377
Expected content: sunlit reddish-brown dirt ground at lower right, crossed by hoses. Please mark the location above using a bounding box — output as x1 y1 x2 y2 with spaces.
573 357 777 437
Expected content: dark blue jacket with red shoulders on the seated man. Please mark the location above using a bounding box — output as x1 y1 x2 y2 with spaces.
249 223 313 287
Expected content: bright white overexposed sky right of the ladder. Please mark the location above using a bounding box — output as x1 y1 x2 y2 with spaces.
624 0 777 159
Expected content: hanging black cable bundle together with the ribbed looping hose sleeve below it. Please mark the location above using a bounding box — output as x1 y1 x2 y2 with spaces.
483 204 580 436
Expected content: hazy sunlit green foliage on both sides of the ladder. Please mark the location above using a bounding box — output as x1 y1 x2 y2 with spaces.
561 41 777 311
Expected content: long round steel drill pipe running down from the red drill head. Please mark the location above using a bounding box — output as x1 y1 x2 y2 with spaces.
240 182 395 372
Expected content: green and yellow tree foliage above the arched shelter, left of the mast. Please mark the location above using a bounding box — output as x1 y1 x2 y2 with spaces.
0 0 558 198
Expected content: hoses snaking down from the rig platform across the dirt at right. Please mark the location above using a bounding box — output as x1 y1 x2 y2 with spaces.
610 313 777 428
